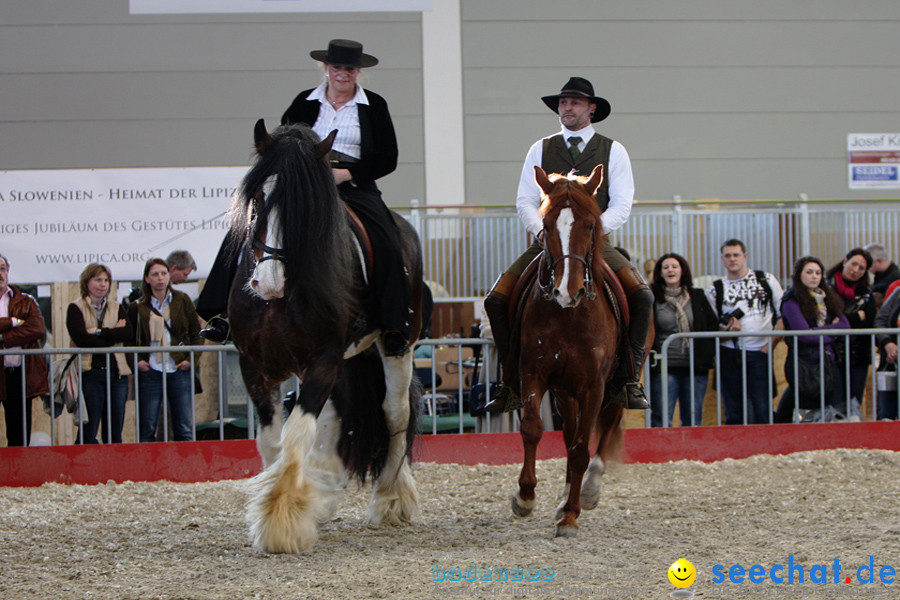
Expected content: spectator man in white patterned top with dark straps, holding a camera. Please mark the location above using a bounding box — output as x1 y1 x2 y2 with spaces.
706 239 784 425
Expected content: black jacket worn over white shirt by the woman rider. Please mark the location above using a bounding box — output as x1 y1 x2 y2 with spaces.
281 90 397 186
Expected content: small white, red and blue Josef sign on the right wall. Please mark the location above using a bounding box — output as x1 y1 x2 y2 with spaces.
847 133 900 190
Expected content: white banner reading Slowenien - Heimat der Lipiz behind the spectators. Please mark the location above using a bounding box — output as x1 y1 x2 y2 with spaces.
0 167 247 284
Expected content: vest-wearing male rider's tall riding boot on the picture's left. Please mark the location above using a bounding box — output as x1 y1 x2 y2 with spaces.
484 272 522 413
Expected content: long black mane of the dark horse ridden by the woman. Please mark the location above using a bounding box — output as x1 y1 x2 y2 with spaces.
231 125 354 319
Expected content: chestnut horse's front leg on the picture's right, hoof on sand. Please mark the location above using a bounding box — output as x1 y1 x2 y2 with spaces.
556 386 600 537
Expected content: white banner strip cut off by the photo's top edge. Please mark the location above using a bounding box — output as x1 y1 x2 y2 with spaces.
128 0 433 15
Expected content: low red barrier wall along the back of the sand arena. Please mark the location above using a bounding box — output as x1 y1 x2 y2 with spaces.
0 422 900 486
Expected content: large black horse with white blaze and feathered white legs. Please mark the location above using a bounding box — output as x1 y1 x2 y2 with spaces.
228 119 422 552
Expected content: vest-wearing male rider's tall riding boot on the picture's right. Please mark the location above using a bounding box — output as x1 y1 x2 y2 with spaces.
616 267 653 410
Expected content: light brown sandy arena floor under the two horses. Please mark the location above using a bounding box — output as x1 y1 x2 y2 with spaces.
0 450 900 600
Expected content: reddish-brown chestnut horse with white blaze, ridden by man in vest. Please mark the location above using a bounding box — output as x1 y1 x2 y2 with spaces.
512 165 623 537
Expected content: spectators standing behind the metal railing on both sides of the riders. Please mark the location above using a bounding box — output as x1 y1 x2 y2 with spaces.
0 239 900 446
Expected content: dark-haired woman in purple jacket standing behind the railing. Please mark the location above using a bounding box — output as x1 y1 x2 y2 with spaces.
774 256 850 423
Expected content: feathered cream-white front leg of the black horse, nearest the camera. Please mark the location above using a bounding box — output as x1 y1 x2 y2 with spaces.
247 415 321 553
